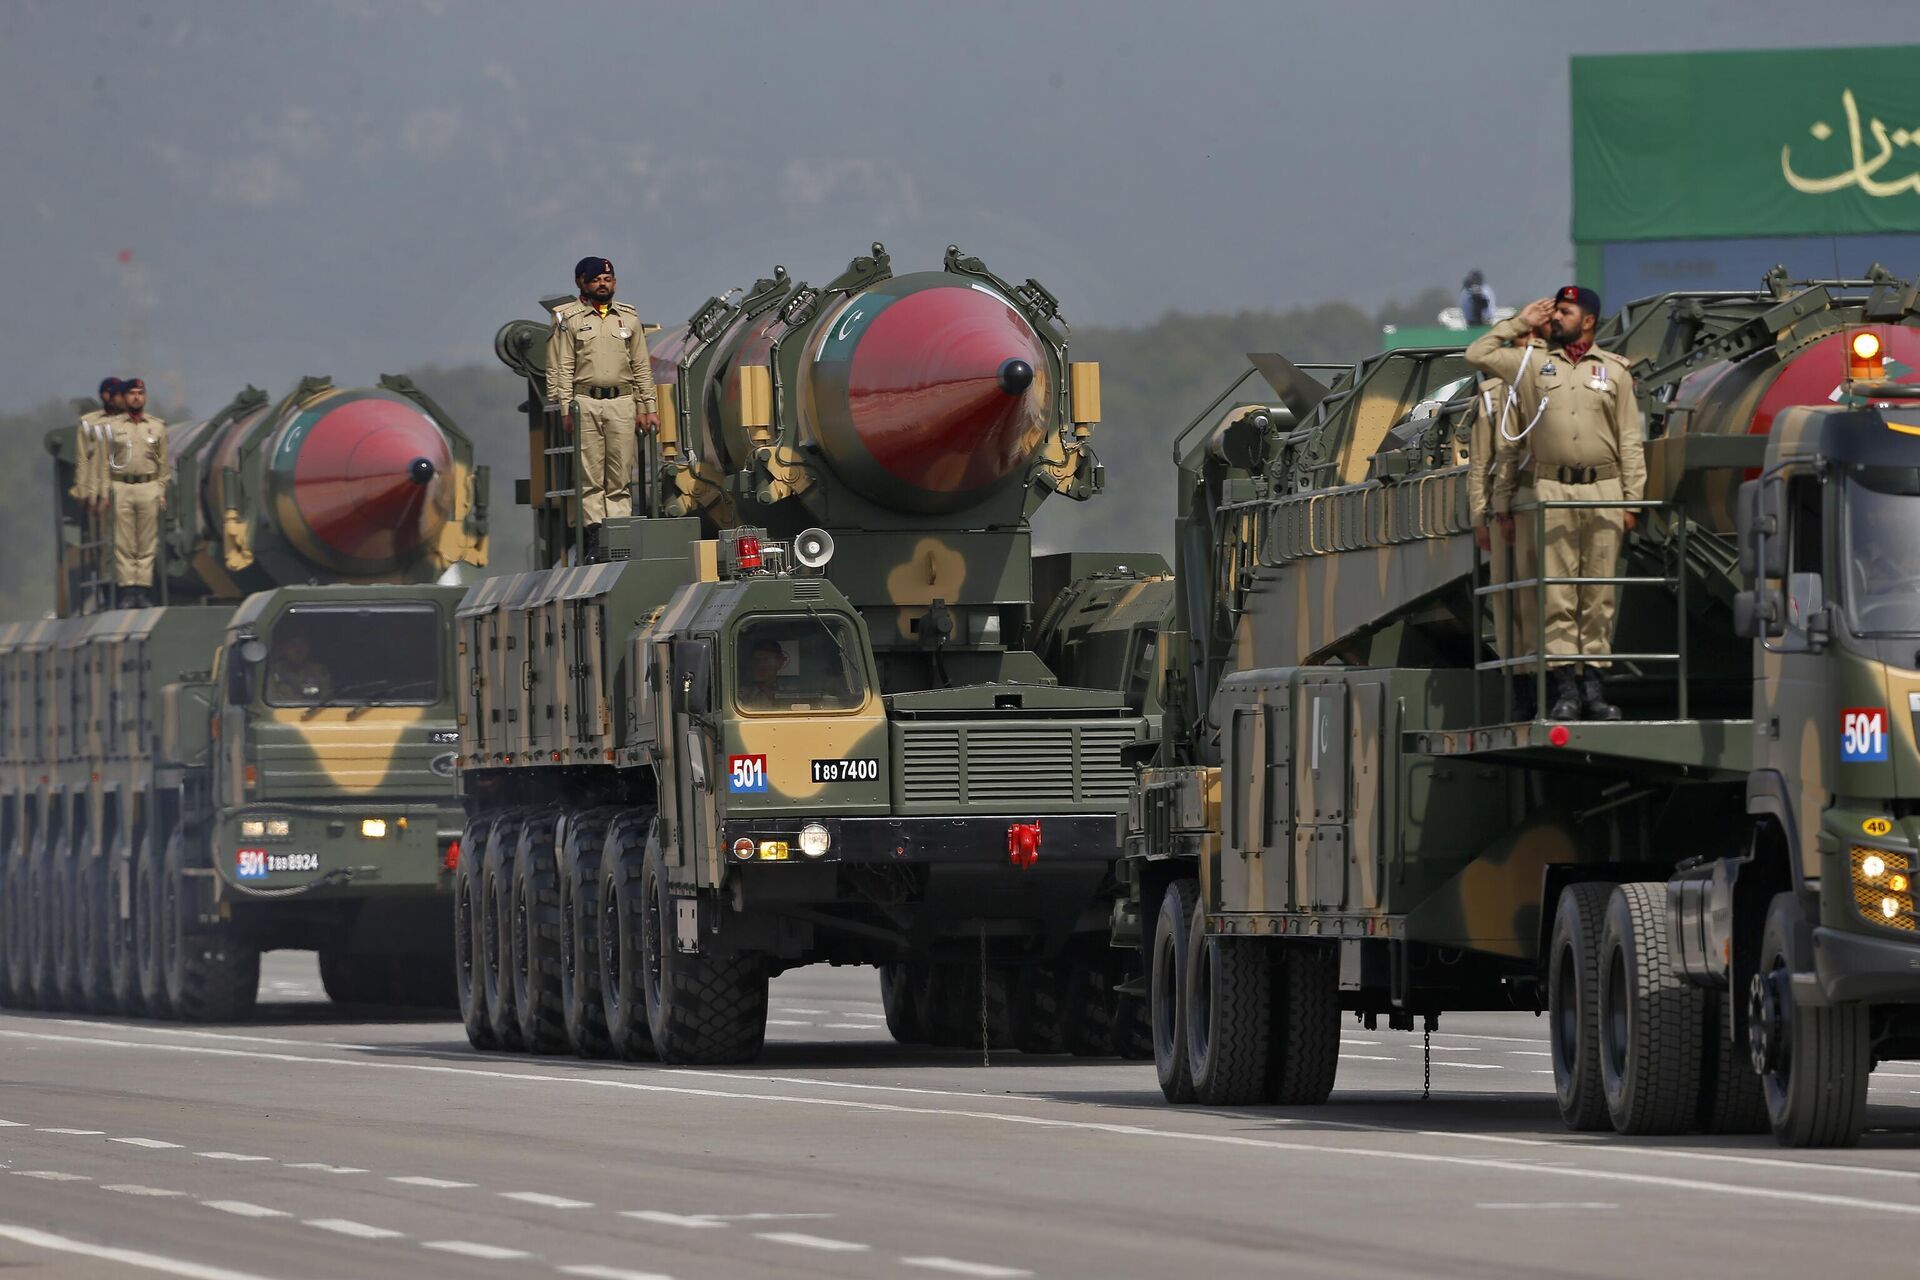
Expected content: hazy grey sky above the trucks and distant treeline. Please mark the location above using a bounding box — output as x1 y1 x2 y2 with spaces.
0 0 1920 413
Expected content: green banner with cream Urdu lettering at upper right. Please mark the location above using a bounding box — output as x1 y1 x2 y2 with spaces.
1572 44 1920 244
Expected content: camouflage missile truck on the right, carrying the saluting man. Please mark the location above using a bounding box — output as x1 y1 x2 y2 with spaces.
1116 267 1920 1146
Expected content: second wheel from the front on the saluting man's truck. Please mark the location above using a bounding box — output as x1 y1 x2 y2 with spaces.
1599 881 1707 1134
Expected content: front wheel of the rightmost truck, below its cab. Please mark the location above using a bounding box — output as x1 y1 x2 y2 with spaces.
1747 894 1872 1148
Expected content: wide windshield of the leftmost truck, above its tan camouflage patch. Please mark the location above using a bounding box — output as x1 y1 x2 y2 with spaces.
265 604 440 706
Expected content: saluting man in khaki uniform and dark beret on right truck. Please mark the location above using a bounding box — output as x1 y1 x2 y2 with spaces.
1467 284 1647 720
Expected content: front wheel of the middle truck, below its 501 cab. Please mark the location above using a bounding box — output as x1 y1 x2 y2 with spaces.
637 825 766 1065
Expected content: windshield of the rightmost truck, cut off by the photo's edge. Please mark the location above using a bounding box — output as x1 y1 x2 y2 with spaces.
1843 466 1920 635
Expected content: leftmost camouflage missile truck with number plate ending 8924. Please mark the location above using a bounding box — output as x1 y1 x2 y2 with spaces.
0 378 486 1019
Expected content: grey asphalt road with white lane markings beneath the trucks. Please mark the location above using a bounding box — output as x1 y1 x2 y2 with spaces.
0 956 1920 1280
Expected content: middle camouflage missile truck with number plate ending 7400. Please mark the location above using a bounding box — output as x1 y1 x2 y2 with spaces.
455 246 1165 1063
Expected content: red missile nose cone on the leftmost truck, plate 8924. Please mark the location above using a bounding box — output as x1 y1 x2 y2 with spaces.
275 393 451 566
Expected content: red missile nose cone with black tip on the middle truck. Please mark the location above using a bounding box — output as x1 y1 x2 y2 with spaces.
814 278 1046 510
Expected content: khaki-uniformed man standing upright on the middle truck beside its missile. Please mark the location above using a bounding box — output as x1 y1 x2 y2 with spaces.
547 257 660 560
